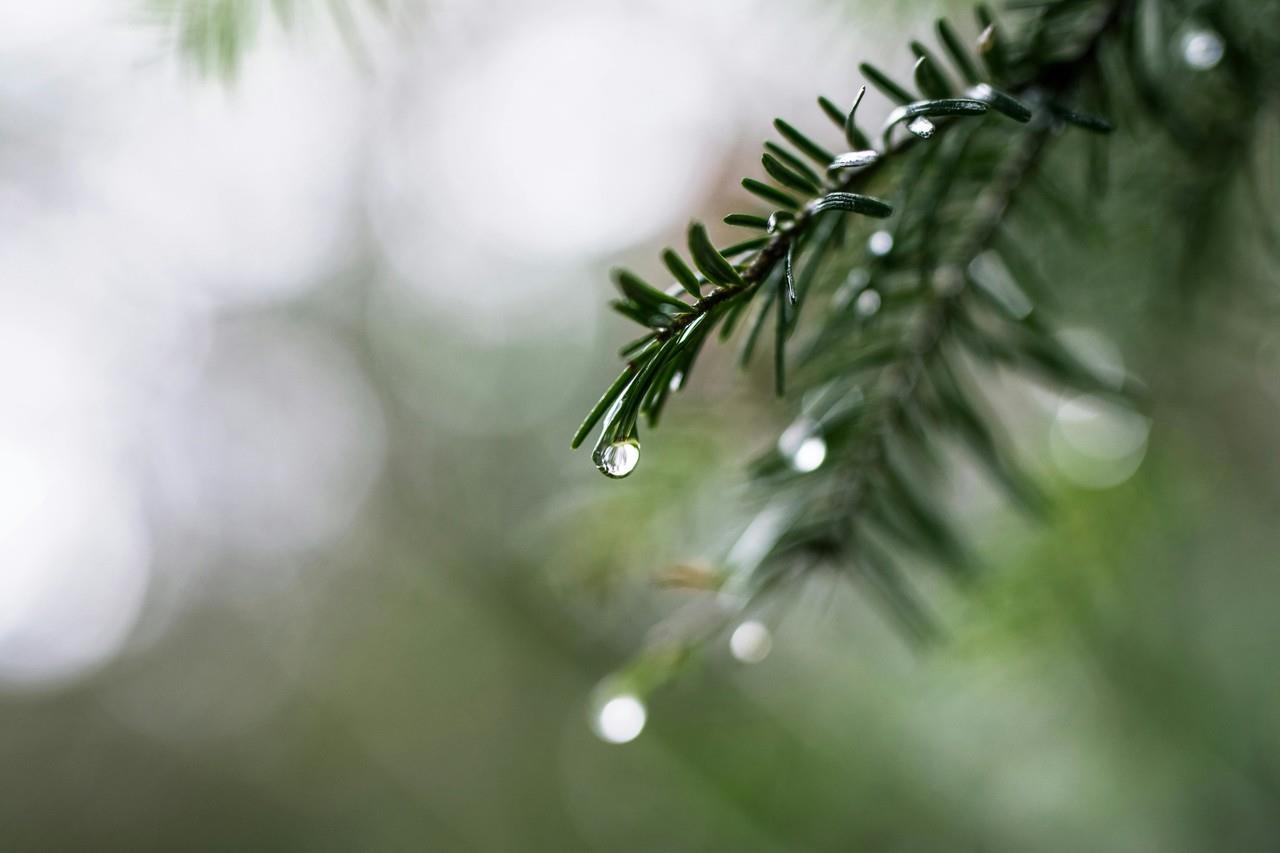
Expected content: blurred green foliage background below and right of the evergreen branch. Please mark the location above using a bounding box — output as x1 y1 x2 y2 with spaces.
0 0 1280 853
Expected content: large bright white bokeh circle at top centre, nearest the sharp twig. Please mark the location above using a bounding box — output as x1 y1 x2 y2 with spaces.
371 6 732 312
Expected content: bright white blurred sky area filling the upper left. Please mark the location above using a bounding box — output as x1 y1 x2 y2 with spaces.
0 0 942 696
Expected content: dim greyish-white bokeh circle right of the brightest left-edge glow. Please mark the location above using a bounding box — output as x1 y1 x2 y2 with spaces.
156 323 385 556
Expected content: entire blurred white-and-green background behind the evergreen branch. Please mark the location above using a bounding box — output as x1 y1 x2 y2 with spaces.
0 0 1280 853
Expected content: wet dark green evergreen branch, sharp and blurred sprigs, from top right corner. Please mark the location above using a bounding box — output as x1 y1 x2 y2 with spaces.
572 0 1276 655
